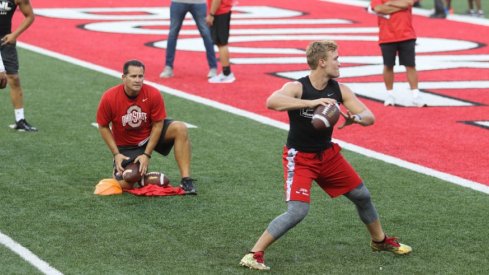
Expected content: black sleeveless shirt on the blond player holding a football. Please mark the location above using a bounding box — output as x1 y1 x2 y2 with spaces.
287 76 343 152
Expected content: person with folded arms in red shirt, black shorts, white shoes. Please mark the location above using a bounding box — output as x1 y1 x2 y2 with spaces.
370 0 425 107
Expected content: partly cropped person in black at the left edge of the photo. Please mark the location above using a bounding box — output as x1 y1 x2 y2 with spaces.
0 0 37 132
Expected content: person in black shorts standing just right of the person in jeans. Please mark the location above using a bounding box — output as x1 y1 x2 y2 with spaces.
206 0 236 83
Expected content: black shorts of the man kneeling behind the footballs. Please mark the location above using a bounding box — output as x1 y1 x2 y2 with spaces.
114 119 174 180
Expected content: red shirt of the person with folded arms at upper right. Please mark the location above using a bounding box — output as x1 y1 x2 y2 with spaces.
370 0 416 43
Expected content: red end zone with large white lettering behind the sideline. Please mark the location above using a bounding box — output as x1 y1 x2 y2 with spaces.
16 0 489 188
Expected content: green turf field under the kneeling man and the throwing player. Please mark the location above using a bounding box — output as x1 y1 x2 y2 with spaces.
0 50 489 274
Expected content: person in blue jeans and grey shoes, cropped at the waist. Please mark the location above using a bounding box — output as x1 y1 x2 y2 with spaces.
160 0 217 78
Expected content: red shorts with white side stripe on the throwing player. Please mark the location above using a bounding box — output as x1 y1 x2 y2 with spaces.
282 143 362 203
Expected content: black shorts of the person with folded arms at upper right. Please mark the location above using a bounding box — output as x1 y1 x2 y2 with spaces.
380 39 416 67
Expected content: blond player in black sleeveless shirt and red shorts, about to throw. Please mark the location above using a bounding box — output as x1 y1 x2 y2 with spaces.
240 41 412 270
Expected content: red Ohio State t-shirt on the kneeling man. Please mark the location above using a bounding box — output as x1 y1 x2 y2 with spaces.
97 84 166 146
